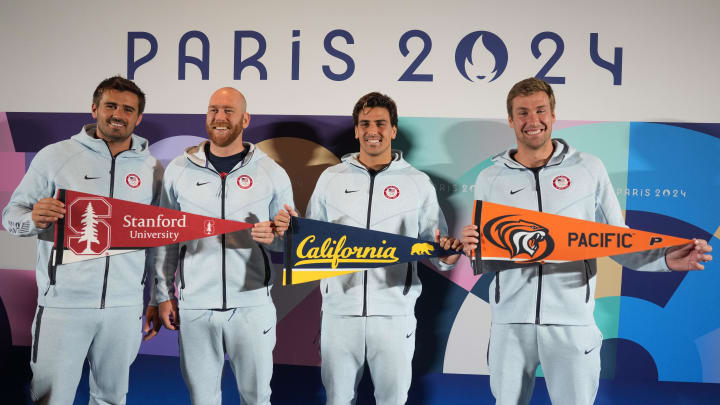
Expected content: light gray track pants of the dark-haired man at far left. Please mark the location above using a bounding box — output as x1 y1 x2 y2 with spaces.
30 305 142 405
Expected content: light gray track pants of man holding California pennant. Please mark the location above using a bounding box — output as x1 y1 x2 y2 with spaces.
320 313 417 405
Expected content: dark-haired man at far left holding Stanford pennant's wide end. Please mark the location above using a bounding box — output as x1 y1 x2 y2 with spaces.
3 76 162 404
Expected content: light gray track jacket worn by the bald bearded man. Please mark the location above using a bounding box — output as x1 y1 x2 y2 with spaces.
155 141 293 309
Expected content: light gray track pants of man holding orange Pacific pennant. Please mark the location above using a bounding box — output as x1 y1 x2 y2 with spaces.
488 324 602 405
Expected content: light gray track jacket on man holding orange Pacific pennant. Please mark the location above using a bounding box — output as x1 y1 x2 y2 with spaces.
475 139 669 325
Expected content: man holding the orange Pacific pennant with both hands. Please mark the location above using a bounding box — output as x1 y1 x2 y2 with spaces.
462 78 712 405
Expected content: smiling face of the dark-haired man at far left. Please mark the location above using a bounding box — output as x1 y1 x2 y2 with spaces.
91 89 142 146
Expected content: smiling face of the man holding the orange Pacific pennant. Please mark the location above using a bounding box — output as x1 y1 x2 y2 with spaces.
508 91 555 156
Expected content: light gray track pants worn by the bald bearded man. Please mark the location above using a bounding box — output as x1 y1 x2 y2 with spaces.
179 304 277 405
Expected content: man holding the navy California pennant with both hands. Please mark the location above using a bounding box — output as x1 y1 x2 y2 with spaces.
275 92 460 405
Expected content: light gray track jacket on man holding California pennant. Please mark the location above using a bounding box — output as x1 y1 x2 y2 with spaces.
307 151 454 316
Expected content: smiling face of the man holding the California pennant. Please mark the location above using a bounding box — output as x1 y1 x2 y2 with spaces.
355 107 397 163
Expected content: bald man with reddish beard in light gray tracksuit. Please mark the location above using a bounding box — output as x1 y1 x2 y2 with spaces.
155 87 293 405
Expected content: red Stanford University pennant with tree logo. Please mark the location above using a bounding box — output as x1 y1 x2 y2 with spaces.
53 189 253 265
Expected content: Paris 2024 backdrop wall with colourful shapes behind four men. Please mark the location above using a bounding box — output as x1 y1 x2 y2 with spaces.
0 1 720 404
